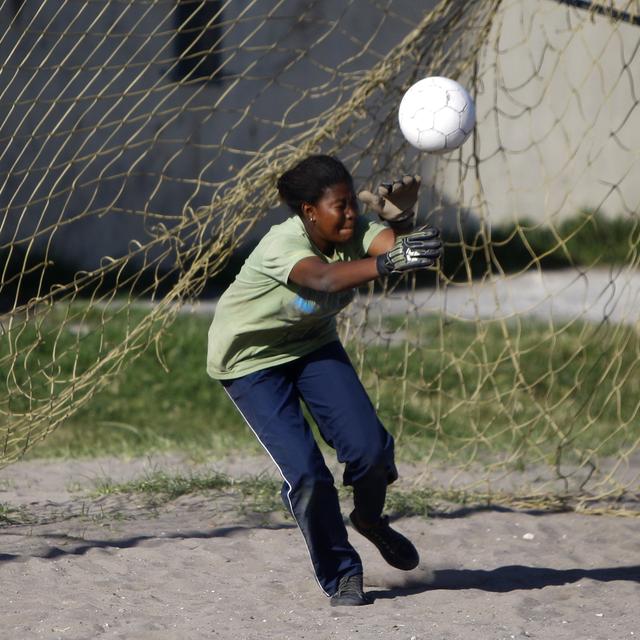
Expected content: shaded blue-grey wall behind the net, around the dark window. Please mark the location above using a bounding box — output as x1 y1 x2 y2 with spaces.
0 0 433 269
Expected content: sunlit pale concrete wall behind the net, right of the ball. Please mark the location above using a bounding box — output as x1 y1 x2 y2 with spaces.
425 0 640 230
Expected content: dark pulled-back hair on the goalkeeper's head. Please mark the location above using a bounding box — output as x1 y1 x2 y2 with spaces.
276 155 353 215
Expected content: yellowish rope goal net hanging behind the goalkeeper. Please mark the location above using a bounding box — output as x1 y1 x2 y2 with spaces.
0 0 640 504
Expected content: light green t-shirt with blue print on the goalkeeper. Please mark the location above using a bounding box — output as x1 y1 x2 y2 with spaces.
207 216 386 380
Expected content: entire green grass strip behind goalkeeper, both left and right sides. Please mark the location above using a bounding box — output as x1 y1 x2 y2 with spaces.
0 272 640 465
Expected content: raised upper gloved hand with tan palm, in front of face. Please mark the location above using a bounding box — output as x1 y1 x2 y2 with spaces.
358 176 420 233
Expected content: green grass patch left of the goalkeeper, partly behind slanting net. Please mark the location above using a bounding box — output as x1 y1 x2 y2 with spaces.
0 309 261 459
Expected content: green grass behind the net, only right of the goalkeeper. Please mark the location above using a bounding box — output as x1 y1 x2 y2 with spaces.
365 317 640 462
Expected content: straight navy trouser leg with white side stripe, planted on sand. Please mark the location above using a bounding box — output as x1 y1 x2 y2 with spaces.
223 365 362 595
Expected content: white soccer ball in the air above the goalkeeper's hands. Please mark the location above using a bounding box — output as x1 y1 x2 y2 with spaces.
398 76 476 153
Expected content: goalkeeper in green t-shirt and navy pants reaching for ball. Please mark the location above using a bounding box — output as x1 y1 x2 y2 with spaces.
207 155 442 605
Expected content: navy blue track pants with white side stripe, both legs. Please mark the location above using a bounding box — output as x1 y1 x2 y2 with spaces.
222 342 398 596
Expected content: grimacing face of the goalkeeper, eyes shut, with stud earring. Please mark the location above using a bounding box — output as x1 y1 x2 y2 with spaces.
302 183 358 251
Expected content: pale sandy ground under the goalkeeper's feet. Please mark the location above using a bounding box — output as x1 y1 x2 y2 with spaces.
0 456 640 640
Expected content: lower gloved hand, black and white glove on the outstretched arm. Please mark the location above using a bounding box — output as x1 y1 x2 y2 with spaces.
376 227 442 276
